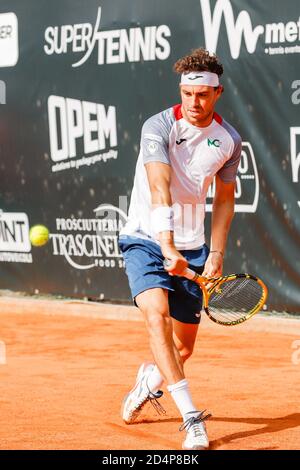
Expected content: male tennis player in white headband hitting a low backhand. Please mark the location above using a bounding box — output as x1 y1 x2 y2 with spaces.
119 48 241 449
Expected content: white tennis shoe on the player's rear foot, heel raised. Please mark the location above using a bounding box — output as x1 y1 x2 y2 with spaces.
121 363 165 424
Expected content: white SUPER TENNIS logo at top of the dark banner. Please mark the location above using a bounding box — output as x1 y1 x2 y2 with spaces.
44 7 171 67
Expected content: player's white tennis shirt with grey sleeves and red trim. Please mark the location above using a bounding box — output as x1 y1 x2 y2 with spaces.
120 104 241 250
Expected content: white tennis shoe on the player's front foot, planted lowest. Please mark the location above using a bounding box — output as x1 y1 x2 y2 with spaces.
179 410 211 450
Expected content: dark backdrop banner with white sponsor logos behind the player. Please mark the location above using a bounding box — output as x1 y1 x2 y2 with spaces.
0 0 300 312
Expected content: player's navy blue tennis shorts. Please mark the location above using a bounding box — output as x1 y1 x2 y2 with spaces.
119 235 209 324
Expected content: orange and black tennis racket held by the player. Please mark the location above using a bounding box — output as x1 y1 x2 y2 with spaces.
164 260 268 326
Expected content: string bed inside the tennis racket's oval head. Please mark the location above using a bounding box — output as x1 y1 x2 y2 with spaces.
208 278 263 323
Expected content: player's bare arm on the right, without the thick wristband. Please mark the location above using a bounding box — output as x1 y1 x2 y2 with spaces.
203 175 235 277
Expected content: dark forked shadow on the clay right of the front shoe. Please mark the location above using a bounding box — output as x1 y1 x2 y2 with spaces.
210 413 300 450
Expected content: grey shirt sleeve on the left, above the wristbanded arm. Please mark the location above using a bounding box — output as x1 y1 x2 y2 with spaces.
141 113 170 165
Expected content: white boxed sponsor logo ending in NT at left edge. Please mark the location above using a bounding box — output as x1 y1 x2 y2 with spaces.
0 211 32 263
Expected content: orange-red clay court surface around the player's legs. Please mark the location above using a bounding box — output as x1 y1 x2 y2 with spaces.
0 299 300 450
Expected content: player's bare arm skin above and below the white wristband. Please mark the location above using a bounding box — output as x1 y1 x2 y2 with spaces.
145 162 188 275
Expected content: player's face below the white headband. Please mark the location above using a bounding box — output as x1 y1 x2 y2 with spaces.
180 85 223 127
